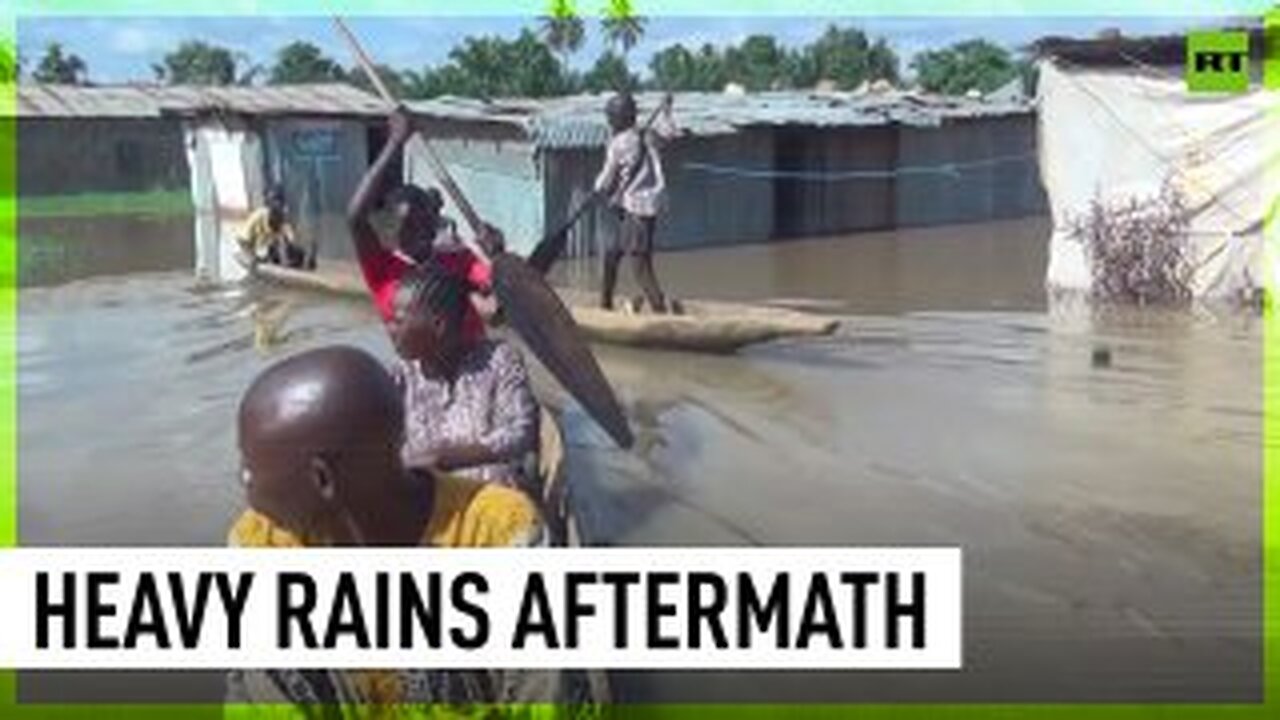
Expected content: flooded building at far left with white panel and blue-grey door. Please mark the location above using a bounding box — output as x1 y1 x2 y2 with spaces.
17 83 387 279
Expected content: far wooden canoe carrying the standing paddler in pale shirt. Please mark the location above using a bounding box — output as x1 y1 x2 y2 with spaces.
255 265 840 354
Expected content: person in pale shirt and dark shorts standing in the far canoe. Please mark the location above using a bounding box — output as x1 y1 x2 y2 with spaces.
595 92 676 313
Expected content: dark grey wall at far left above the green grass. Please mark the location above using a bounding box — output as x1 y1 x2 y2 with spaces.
18 118 188 195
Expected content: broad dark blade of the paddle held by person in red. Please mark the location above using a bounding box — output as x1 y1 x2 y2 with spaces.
493 252 635 448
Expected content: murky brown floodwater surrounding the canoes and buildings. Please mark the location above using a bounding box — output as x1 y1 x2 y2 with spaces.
18 219 1262 702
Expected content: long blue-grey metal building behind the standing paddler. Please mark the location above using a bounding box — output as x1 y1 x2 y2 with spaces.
406 91 1044 252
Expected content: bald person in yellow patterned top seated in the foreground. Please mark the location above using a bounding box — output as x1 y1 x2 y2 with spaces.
228 346 570 717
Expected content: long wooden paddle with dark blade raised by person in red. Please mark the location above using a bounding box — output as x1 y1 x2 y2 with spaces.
333 18 635 448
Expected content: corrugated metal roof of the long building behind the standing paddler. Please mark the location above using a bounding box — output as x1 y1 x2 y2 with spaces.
410 91 1032 149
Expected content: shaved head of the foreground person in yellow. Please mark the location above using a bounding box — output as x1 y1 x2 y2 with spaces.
238 346 410 544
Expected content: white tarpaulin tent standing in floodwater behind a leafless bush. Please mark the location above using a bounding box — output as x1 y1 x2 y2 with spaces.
1037 60 1280 297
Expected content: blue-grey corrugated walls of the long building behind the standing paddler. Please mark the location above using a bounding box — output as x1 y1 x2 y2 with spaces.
406 117 1044 255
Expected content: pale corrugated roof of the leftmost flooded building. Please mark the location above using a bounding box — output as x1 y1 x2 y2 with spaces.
18 83 387 118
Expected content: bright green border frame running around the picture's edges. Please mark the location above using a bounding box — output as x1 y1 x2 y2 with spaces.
0 0 1280 720
